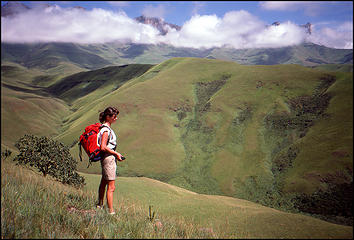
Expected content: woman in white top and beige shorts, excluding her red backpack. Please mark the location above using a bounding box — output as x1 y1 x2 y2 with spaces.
97 107 124 215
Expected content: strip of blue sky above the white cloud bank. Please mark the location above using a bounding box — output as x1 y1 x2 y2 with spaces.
9 1 353 26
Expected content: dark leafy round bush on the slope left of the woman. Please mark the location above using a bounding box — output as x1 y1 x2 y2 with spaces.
14 134 85 187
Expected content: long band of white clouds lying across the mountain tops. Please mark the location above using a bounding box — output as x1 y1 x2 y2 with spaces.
1 5 353 48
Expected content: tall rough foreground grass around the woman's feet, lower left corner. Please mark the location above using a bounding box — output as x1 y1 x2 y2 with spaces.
1 161 221 239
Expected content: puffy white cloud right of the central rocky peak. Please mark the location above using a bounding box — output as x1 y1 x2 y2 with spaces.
165 10 305 48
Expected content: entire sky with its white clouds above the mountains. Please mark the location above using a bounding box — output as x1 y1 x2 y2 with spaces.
1 1 353 49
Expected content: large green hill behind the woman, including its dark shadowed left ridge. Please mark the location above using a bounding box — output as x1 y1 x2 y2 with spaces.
2 58 353 224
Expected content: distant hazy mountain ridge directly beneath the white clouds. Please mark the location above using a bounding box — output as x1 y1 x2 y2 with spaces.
1 43 353 74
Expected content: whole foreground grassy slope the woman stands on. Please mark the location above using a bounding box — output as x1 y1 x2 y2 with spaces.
1 159 353 239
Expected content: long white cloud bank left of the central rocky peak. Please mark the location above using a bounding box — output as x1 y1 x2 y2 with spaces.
1 7 159 43
